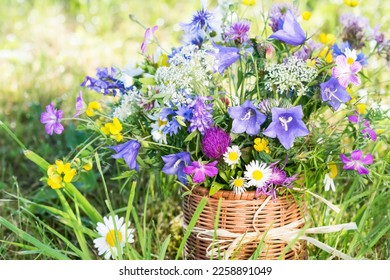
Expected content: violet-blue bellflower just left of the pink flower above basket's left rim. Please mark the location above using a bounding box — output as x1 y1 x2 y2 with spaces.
162 152 191 185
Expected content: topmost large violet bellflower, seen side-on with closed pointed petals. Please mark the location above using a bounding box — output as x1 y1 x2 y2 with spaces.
269 10 306 46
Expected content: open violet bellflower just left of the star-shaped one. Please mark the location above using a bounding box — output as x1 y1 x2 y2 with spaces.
228 100 266 135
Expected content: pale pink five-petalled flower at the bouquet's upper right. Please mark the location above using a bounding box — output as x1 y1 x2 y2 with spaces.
332 55 362 88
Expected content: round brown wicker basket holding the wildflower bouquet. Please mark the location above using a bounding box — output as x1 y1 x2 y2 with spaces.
183 187 307 260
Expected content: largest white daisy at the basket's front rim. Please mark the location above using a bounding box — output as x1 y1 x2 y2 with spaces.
244 160 272 188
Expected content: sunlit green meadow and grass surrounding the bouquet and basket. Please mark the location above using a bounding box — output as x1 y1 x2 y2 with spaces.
0 0 390 259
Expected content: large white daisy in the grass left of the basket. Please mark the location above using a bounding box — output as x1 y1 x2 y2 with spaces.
93 215 134 259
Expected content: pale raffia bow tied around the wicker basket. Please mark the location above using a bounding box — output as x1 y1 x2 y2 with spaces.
183 192 357 260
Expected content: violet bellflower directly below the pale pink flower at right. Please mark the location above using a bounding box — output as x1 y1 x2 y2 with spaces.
320 77 351 110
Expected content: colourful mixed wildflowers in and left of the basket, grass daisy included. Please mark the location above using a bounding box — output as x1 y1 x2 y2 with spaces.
2 0 389 257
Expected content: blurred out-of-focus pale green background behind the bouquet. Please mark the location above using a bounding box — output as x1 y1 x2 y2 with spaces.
0 0 390 259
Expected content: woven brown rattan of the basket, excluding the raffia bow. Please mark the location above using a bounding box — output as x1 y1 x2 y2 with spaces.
183 187 307 260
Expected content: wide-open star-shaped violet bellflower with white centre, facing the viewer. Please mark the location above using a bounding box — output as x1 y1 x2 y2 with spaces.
263 105 309 150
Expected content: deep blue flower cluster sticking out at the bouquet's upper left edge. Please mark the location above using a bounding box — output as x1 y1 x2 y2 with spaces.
81 67 127 96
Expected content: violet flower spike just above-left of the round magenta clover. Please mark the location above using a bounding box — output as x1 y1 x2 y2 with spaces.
188 96 213 135
